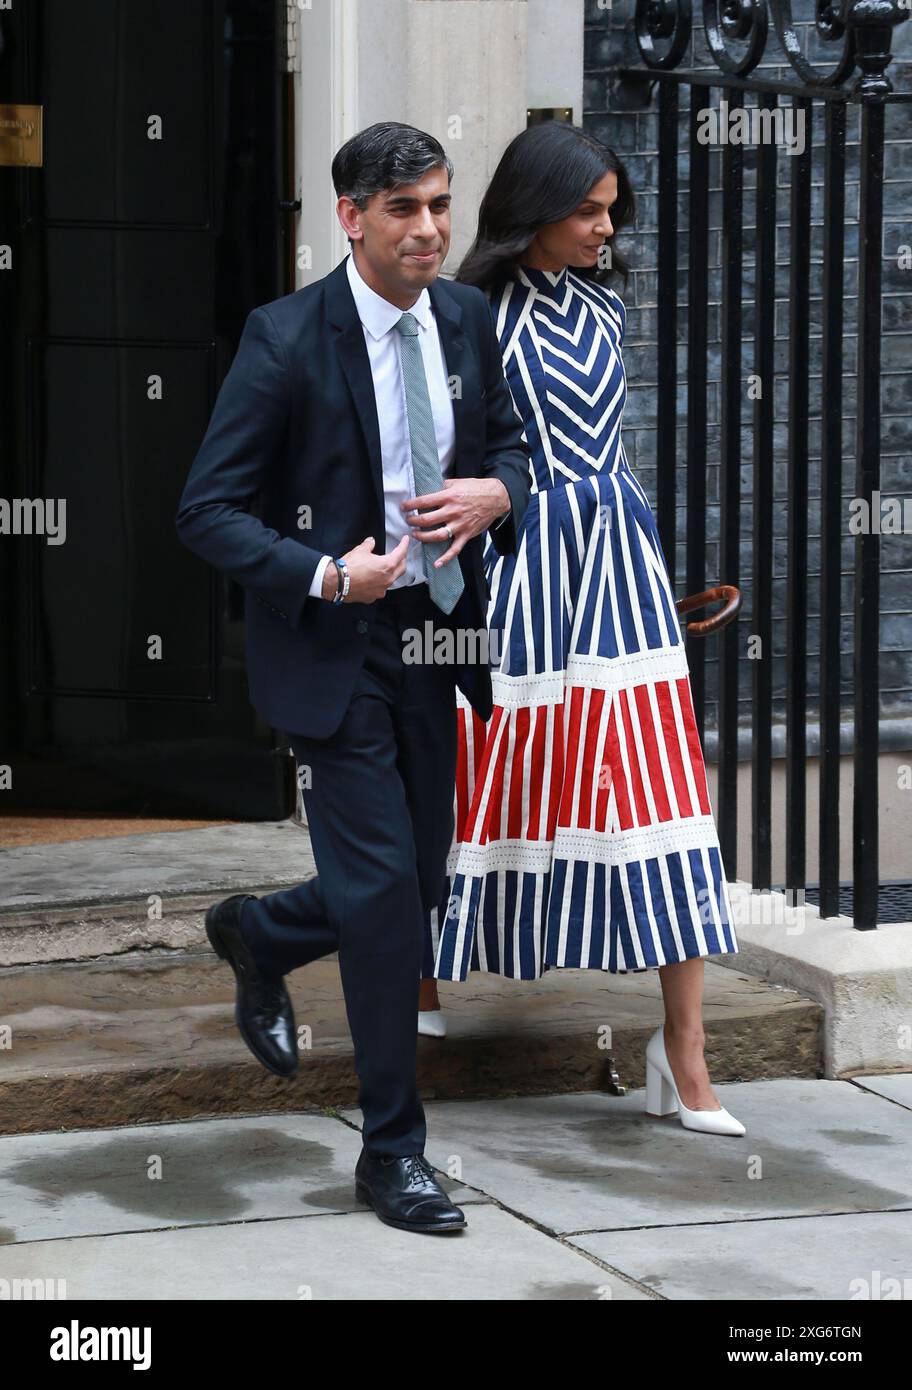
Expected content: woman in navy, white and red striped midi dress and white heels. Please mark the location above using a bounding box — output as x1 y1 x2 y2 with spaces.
420 122 744 1134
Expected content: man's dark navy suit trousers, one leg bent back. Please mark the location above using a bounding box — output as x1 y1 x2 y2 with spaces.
242 584 456 1156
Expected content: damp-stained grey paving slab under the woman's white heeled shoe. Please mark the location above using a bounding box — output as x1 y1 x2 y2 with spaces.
350 1079 912 1234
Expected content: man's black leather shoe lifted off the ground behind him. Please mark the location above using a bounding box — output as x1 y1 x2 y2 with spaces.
206 892 298 1076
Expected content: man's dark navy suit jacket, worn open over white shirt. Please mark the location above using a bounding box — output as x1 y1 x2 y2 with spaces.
177 260 531 738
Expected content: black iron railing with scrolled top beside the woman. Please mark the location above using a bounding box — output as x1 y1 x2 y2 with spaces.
619 0 912 929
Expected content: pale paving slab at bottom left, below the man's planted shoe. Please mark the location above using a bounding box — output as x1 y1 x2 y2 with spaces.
0 1202 652 1302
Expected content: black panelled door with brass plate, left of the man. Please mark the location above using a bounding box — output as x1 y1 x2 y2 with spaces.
0 0 293 820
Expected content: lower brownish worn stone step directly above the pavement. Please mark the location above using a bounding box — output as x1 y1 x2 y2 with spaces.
0 945 823 1134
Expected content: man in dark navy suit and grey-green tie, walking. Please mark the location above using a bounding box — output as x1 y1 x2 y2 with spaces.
178 122 530 1232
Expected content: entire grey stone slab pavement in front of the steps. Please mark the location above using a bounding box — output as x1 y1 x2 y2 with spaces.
0 1074 912 1301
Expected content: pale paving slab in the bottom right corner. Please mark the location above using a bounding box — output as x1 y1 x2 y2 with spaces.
569 1212 912 1306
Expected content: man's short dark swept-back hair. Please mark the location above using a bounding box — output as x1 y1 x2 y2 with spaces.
332 121 453 210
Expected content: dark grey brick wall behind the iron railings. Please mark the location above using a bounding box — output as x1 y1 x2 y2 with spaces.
583 0 912 727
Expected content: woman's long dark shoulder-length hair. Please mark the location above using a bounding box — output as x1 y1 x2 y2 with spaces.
456 121 635 289
